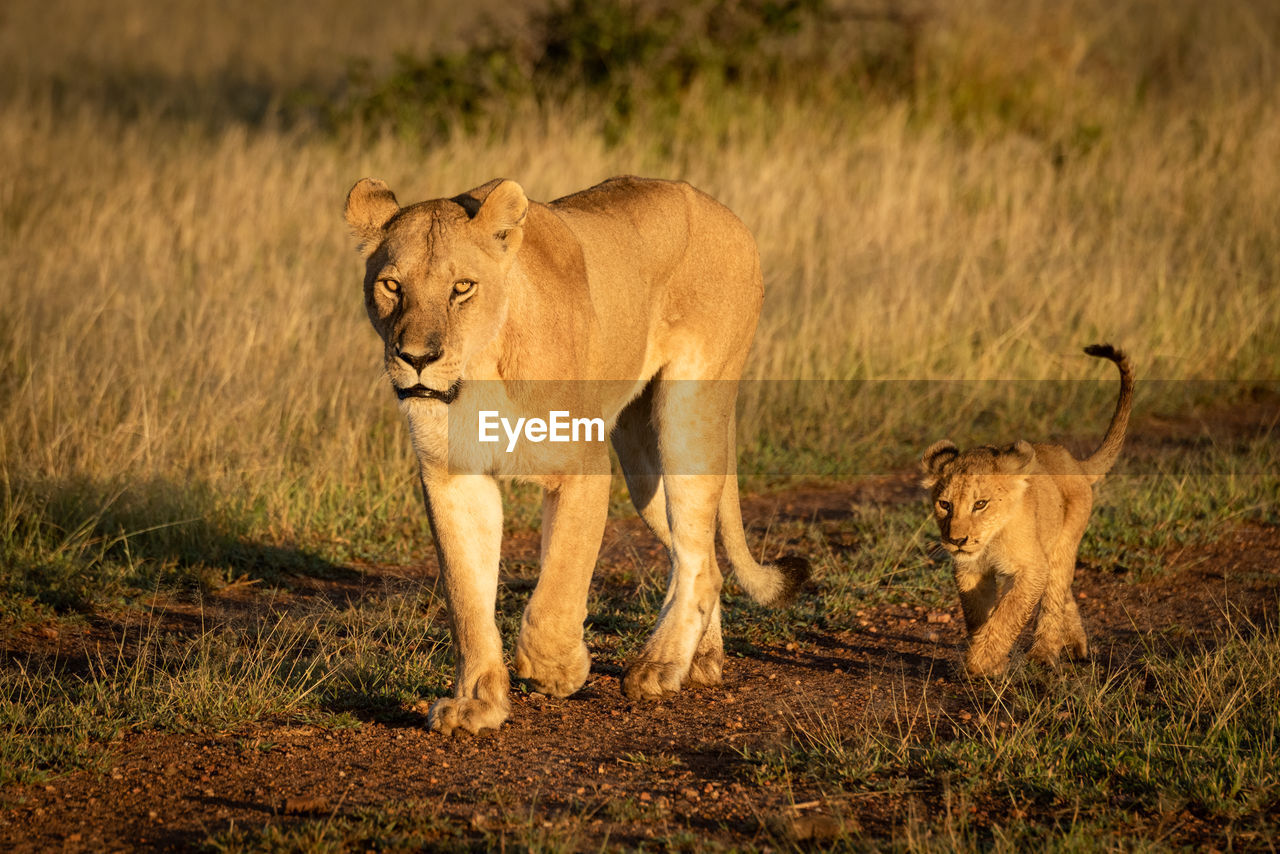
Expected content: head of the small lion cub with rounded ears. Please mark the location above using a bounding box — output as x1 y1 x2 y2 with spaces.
920 439 1036 562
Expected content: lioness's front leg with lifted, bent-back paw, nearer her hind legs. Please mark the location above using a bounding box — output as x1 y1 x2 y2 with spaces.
516 463 609 697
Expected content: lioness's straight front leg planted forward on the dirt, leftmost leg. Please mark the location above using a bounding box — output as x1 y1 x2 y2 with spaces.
424 474 509 735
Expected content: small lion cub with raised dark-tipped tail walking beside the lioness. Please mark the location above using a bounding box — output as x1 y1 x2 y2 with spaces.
922 344 1133 676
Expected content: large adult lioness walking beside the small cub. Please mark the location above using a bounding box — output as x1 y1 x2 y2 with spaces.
346 178 806 734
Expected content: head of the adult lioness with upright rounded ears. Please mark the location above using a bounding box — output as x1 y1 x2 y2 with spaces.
346 178 529 403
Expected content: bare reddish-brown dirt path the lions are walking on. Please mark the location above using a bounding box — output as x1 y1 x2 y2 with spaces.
0 476 1280 851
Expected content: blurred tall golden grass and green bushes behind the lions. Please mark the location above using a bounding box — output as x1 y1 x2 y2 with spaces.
0 0 1280 618
